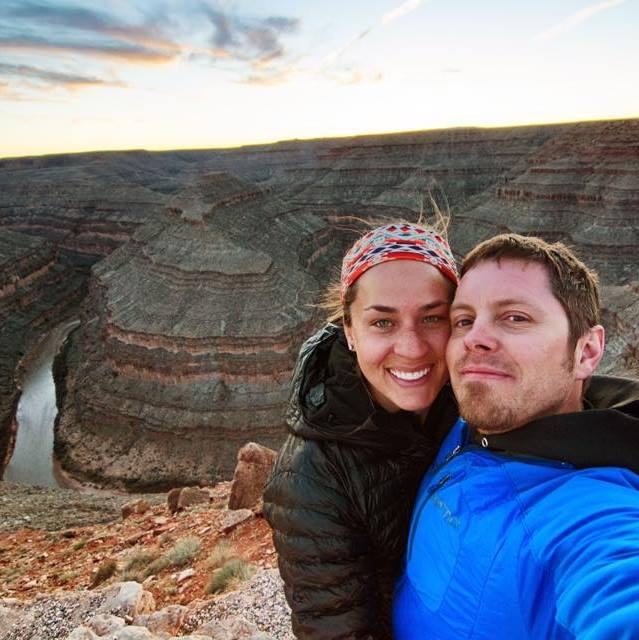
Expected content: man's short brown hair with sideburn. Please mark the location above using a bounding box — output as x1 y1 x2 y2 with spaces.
461 233 601 348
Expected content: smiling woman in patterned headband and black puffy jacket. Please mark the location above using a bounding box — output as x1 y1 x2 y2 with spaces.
264 223 457 640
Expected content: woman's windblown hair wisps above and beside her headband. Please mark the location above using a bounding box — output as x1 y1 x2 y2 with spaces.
318 202 450 326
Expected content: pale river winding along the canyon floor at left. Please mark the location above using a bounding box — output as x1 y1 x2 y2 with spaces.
4 320 79 487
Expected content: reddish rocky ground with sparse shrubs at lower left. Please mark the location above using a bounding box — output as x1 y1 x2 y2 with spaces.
0 482 293 640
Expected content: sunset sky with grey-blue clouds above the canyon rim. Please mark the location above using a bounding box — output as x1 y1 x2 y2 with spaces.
0 0 639 157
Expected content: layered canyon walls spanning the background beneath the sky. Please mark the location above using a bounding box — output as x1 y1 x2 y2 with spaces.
0 120 639 490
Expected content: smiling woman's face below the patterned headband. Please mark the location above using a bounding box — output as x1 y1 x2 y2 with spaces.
344 260 453 416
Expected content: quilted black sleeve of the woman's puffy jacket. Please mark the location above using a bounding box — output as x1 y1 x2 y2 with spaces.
264 435 386 640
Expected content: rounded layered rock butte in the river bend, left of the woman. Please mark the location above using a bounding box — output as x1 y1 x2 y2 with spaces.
56 173 317 488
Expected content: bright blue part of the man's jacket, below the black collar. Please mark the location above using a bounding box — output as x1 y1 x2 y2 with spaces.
393 403 639 640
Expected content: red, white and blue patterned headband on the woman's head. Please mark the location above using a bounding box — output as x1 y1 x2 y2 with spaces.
340 223 459 302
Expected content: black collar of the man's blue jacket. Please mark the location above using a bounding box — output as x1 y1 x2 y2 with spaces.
471 376 639 473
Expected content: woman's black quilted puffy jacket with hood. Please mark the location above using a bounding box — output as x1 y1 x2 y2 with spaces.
264 325 457 640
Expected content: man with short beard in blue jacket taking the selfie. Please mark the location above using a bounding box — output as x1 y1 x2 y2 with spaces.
394 234 639 640
